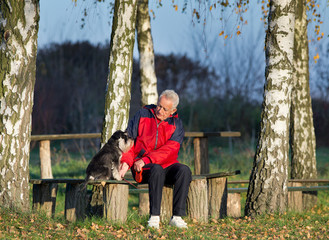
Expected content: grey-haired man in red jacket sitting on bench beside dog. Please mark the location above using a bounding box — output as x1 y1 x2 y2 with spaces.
120 90 192 228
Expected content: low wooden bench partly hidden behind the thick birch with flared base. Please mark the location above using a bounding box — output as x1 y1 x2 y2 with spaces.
227 179 329 217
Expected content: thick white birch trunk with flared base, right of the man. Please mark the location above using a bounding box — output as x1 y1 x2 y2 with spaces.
245 0 295 216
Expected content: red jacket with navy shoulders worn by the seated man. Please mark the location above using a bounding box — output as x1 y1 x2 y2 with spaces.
121 105 184 168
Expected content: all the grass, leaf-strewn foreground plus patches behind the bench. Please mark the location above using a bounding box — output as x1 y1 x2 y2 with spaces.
12 142 329 239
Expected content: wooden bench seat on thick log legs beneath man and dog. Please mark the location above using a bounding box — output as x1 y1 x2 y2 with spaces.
30 171 240 222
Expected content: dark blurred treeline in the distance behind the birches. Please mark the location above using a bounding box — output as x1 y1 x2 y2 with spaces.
32 42 329 146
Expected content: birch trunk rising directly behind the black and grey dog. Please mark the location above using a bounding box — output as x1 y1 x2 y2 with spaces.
101 0 137 145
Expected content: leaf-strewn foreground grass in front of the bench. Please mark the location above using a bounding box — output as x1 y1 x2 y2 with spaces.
0 192 329 239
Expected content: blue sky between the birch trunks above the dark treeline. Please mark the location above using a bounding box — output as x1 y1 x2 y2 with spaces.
38 0 329 98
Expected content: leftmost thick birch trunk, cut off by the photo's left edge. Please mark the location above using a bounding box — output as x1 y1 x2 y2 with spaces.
0 0 39 210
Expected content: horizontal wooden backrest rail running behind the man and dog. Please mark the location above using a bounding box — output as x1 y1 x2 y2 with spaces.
31 131 241 141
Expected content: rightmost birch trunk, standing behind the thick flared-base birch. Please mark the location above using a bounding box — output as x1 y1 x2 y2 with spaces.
291 0 317 209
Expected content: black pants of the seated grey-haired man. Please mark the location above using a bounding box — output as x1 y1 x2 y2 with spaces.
132 163 192 216
